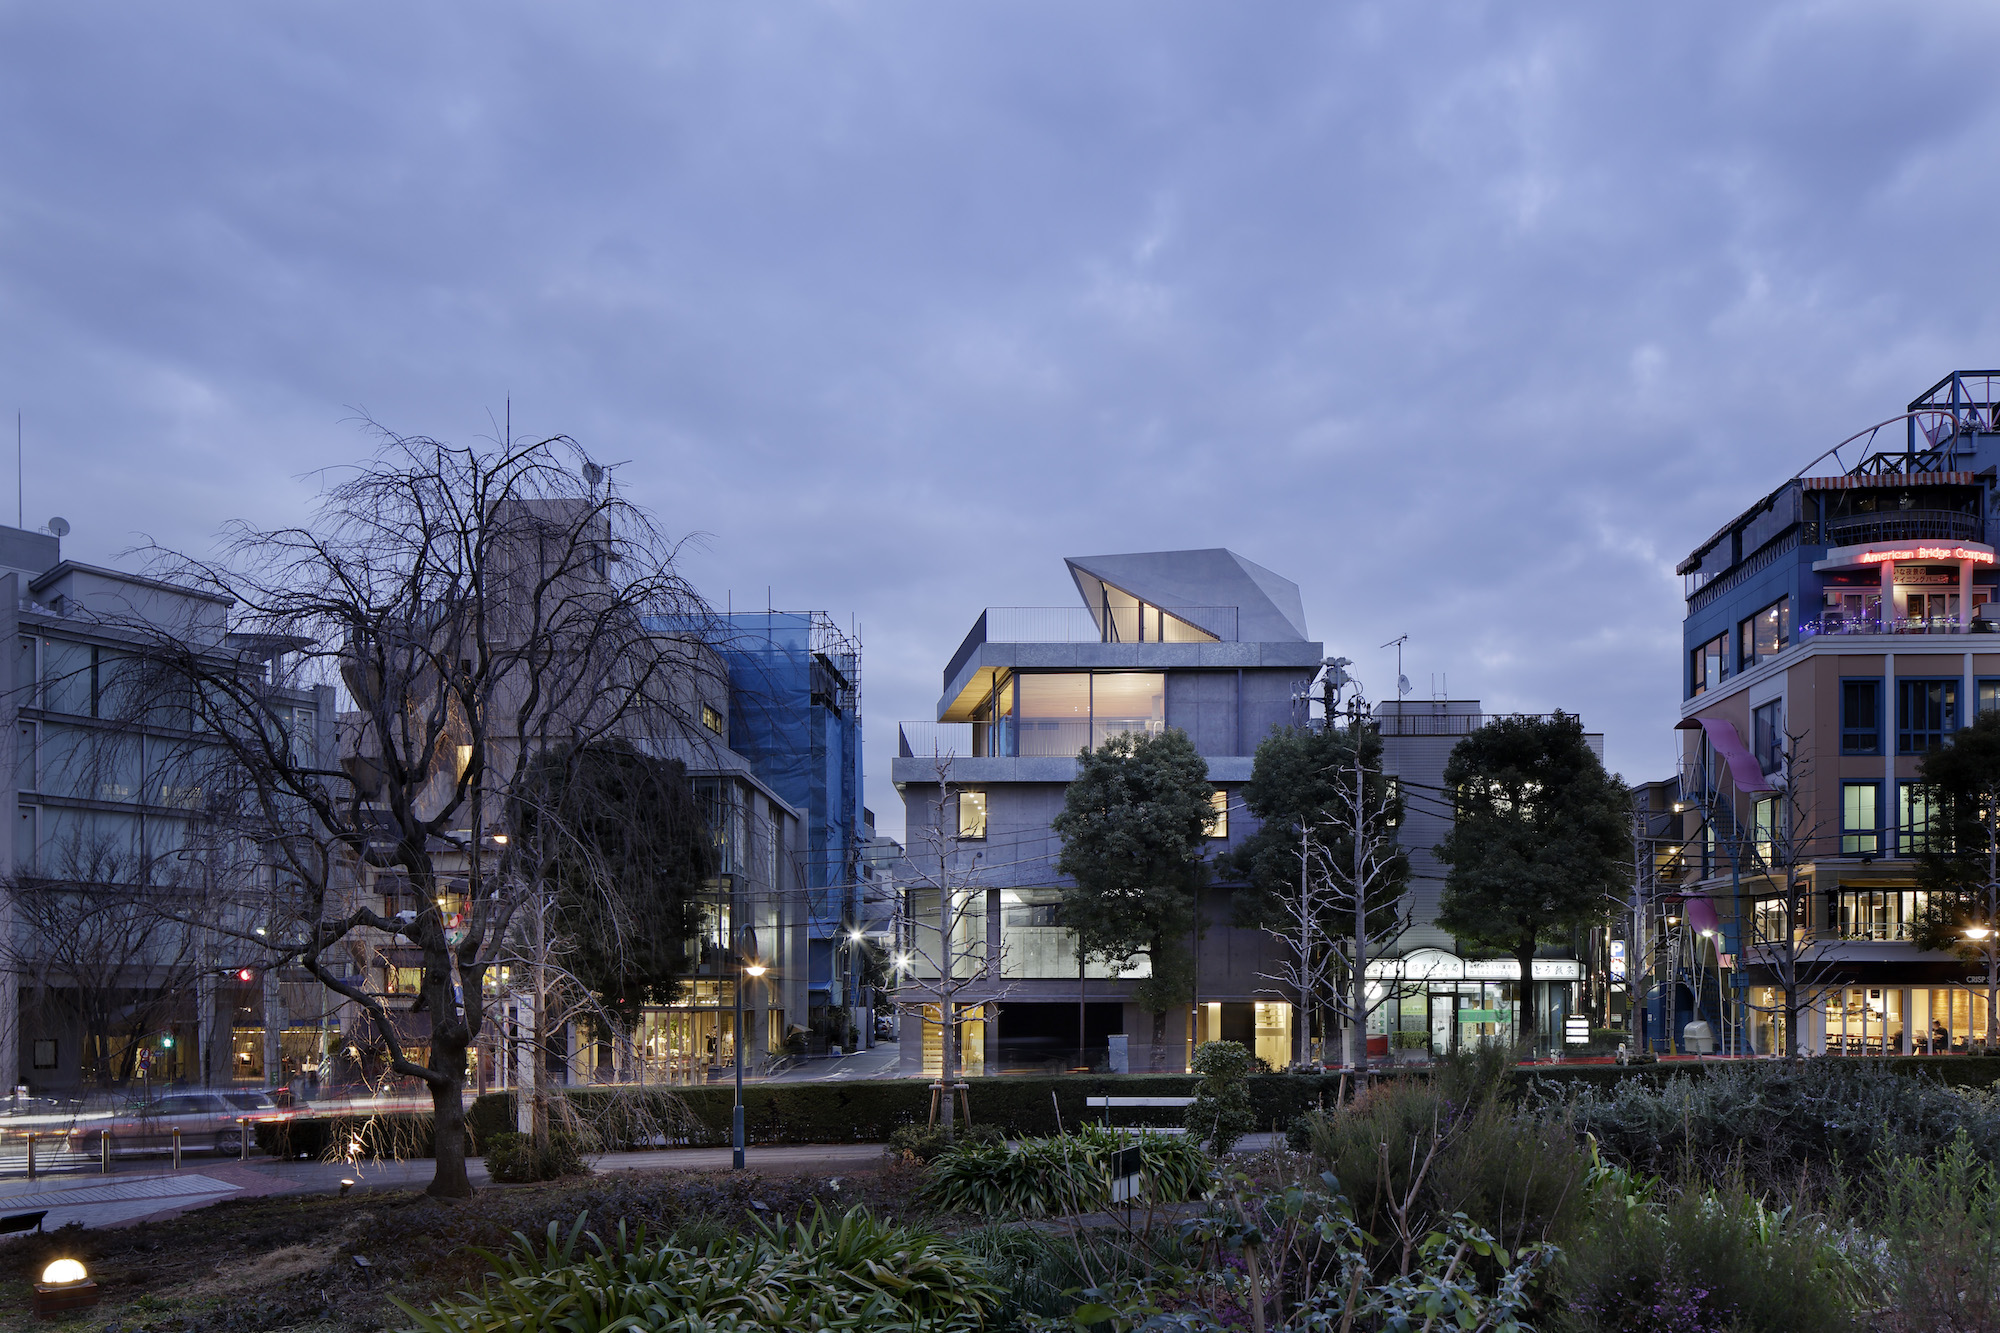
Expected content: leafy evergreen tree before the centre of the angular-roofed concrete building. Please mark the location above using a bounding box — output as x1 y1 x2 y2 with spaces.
1052 729 1214 1047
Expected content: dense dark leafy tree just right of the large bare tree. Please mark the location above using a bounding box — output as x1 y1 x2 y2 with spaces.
508 739 718 1088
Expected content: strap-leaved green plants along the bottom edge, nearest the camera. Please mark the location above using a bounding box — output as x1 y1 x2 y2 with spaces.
398 1207 1004 1333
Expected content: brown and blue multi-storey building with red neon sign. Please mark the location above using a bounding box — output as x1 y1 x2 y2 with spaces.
1648 370 2000 1053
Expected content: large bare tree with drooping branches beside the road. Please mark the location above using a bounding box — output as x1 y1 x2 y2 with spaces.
128 430 716 1197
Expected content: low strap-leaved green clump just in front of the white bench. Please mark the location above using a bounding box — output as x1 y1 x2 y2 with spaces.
924 1127 1210 1217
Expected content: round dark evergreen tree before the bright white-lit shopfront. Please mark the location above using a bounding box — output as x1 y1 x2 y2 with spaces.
1436 713 1632 1033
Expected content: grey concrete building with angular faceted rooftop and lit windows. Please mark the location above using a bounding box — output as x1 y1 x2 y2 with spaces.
892 550 1324 1073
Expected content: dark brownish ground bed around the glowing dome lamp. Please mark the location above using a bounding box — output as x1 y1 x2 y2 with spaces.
0 1165 914 1333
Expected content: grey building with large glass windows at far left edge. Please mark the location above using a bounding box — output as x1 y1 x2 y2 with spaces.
0 520 340 1093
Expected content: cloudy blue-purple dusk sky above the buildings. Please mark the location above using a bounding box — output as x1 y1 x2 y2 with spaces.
0 0 2000 831
